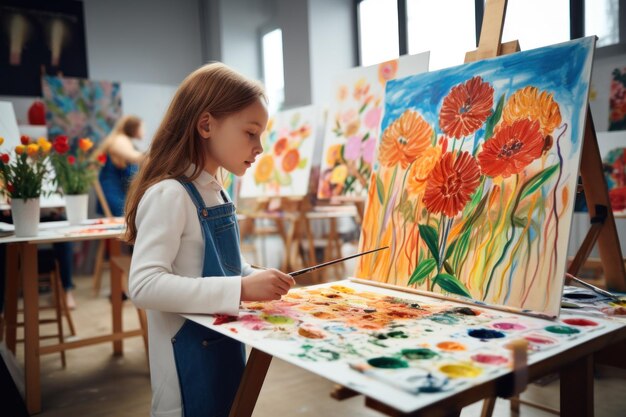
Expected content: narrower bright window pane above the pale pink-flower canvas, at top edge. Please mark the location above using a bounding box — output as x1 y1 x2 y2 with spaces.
358 0 399 66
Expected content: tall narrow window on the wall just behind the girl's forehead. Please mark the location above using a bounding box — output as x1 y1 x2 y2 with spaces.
262 29 285 114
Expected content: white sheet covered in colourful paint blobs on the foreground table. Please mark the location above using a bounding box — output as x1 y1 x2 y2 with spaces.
185 280 623 412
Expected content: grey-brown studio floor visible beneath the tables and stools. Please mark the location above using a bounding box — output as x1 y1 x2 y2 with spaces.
8 277 626 417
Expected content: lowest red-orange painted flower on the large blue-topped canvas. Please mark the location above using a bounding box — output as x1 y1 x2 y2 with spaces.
423 152 480 217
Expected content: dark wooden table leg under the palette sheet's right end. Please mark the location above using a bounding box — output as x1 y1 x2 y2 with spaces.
561 355 593 417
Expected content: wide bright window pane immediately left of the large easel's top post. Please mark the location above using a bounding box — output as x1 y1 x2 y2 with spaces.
407 0 476 71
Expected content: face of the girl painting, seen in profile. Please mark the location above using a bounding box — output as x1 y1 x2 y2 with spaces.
205 99 268 176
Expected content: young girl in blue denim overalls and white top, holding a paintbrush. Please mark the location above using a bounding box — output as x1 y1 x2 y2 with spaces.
126 63 294 417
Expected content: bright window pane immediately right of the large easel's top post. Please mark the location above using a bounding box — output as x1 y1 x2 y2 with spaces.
502 0 570 51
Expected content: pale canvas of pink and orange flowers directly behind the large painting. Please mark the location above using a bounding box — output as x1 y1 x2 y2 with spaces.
317 52 429 199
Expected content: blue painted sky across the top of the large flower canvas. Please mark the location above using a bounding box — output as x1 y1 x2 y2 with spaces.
381 36 595 151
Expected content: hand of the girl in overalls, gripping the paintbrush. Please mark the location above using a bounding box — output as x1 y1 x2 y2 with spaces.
241 269 296 301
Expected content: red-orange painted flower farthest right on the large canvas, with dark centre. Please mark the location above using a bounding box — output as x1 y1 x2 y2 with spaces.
478 119 545 178
